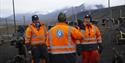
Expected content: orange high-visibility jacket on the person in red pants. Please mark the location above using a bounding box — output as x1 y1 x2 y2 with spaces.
80 24 102 47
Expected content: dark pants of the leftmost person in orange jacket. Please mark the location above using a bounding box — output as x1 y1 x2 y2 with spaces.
32 45 48 63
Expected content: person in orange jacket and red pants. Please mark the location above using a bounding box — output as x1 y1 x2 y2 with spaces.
80 15 102 63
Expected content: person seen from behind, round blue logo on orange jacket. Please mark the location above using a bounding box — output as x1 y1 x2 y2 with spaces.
46 12 82 63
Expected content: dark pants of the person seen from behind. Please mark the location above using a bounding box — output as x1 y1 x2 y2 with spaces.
49 53 76 63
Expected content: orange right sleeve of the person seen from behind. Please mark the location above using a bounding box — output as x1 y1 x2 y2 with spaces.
71 27 83 40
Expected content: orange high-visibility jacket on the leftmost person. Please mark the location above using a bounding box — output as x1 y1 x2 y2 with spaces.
25 23 47 45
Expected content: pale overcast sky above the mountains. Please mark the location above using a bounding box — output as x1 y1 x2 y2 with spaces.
0 0 125 17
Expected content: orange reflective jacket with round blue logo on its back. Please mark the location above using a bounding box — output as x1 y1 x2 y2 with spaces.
46 23 82 54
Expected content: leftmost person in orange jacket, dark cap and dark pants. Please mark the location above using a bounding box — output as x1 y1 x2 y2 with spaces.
25 15 48 63
